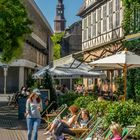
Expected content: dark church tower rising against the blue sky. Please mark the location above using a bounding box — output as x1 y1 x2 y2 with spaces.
54 0 66 33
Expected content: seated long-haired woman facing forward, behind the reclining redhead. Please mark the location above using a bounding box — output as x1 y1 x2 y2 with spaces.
76 110 90 128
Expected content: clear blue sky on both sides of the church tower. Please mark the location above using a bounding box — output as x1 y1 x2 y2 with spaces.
35 0 84 29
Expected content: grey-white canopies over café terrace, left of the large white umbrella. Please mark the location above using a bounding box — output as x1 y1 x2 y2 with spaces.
33 55 106 79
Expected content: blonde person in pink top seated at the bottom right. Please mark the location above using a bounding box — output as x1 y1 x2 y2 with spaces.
110 123 122 140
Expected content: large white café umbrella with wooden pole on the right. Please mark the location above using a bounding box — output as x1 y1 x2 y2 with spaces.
89 49 140 99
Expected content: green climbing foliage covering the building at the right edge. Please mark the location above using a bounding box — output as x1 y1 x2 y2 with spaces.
122 0 140 99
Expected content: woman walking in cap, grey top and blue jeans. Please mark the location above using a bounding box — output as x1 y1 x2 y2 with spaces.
25 89 42 140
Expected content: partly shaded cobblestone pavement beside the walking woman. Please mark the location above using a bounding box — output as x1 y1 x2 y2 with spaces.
0 96 45 140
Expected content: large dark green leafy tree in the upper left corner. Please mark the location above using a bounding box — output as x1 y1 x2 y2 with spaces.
0 0 32 63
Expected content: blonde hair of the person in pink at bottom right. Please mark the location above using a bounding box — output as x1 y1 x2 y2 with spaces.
110 122 122 135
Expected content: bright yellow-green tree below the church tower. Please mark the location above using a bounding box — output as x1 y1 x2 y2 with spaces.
51 32 64 60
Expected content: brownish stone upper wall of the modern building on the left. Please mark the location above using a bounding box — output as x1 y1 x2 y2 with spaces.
21 0 52 66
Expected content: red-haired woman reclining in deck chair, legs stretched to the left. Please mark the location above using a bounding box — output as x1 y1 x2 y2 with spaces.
44 105 78 137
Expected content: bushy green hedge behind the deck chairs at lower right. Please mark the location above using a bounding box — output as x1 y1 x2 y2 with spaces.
73 96 140 137
